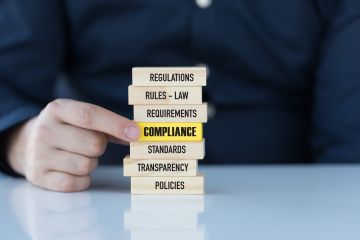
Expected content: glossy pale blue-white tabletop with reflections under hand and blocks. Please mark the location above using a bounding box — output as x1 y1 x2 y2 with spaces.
0 165 360 240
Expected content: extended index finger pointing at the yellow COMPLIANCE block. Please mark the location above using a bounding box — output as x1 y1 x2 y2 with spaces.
50 99 140 141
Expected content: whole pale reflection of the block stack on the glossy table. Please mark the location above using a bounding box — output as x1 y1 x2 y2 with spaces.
124 195 205 240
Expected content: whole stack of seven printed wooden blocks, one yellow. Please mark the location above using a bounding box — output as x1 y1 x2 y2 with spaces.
124 67 207 194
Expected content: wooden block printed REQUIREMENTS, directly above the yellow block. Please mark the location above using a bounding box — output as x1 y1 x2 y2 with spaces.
134 103 207 122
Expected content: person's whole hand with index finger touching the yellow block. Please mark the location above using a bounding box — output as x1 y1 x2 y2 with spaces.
7 99 139 192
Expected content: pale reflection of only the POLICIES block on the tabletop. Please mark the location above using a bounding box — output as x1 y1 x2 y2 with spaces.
131 195 205 213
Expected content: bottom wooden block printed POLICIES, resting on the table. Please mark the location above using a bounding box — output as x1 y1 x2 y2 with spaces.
131 174 204 194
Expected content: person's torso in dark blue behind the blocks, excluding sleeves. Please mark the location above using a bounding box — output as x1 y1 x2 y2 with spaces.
59 0 338 163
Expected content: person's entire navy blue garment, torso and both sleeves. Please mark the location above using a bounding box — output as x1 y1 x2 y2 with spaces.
0 0 360 170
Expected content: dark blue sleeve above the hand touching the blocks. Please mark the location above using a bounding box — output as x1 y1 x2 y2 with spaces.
0 0 65 172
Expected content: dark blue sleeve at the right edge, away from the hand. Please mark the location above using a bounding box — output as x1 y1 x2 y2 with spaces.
312 0 360 162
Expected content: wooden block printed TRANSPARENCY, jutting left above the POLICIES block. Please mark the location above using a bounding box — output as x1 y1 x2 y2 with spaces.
123 156 197 177
